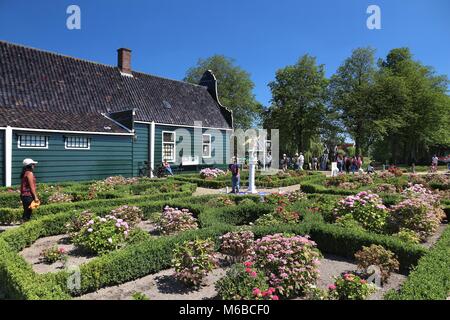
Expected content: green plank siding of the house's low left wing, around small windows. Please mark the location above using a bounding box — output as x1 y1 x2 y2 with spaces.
12 131 133 185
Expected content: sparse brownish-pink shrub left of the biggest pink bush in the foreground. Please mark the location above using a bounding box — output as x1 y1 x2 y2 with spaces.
172 239 217 287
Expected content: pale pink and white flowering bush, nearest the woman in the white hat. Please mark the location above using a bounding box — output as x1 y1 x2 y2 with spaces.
73 215 129 254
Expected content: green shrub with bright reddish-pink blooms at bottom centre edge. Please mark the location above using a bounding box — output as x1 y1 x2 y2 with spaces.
215 262 269 300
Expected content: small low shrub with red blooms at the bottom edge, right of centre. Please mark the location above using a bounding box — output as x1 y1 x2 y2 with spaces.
328 273 376 300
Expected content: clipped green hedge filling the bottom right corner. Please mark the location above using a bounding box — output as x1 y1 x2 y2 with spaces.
385 228 450 300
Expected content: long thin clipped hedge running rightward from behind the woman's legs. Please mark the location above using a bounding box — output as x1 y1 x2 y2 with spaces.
0 184 197 224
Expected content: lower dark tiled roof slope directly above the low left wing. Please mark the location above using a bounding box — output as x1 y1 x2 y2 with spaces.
0 107 129 133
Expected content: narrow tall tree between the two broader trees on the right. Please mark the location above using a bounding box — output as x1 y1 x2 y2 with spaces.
330 48 383 154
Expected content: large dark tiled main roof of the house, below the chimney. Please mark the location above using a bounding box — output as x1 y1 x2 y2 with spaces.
0 41 230 129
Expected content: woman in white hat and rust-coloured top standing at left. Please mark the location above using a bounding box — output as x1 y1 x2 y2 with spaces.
20 159 39 221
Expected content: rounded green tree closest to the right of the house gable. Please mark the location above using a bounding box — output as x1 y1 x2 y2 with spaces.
264 55 328 153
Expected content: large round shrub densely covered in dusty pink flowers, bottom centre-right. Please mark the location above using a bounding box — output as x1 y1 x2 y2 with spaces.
254 234 321 297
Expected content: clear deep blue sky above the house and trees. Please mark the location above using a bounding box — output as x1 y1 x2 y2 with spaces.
0 0 450 105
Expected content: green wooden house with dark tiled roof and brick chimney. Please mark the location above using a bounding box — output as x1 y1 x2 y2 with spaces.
0 41 233 186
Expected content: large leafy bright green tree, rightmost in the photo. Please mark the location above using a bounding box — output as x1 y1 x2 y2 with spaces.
375 48 450 163
